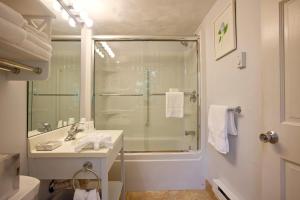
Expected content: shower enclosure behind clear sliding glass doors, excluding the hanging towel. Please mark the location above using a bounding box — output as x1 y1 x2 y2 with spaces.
93 39 199 152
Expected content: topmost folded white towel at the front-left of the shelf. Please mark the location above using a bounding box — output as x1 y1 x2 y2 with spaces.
0 2 26 27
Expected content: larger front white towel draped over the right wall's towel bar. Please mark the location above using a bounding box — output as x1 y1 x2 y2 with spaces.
208 105 229 154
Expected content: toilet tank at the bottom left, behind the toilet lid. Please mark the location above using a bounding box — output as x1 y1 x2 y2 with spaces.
0 153 20 200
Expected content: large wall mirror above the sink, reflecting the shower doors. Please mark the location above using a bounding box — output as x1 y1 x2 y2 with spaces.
28 41 80 137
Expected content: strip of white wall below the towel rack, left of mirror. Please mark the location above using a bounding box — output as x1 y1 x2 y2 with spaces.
0 72 27 174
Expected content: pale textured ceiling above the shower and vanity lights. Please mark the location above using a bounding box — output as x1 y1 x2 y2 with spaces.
41 0 216 36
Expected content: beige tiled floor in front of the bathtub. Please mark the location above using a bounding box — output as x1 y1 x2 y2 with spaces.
127 190 216 200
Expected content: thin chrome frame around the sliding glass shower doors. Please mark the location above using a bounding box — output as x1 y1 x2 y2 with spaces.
91 35 203 153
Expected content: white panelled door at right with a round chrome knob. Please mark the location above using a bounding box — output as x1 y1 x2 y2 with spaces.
261 0 300 200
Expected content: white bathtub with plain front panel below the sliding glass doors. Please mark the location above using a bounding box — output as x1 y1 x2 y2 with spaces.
110 138 206 191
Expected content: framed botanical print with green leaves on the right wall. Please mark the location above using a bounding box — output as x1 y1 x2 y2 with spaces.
213 0 236 60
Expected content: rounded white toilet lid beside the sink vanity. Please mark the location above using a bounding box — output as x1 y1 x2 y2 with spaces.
8 176 40 200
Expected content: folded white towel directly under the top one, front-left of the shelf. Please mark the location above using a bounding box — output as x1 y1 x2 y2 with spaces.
0 17 26 44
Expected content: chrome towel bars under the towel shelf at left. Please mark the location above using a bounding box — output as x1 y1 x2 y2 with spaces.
0 58 43 74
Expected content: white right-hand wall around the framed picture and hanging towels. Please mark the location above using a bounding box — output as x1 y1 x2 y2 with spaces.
199 0 262 200
